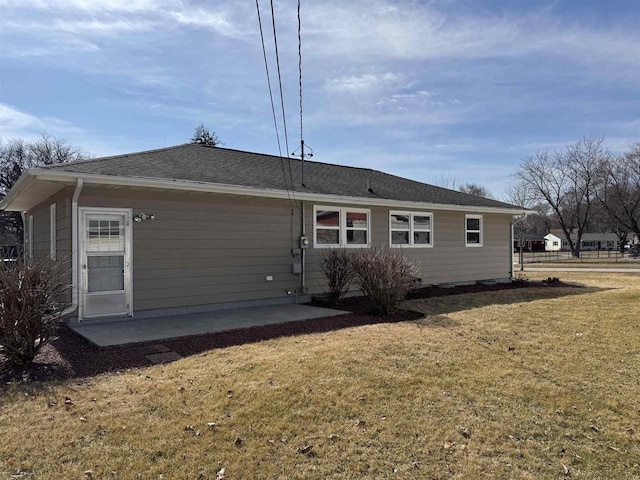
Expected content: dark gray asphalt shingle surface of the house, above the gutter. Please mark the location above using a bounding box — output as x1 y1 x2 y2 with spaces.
44 144 520 210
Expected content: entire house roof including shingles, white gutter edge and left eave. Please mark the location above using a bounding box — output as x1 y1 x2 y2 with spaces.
0 144 524 214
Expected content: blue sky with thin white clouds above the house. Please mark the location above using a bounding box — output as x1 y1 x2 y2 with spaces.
0 0 640 198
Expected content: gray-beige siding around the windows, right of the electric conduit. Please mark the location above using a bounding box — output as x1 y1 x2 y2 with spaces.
306 203 511 293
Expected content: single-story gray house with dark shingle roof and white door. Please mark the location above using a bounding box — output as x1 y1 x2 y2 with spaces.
0 144 525 322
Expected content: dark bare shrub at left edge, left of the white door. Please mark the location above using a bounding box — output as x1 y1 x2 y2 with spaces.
0 257 68 365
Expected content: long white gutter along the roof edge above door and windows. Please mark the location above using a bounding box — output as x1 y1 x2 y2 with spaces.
23 169 533 215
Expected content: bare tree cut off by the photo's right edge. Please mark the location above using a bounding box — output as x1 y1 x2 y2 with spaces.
598 142 640 240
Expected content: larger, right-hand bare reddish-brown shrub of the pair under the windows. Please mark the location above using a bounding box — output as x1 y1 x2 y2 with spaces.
351 246 420 315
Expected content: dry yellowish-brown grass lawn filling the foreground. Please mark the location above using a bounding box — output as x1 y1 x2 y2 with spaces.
0 272 640 479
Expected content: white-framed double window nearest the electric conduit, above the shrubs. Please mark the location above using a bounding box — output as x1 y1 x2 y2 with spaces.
313 206 371 248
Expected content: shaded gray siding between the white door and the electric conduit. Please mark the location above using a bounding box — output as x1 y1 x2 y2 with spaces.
79 188 300 311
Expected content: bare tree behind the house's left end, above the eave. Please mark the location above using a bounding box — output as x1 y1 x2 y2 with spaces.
0 134 88 242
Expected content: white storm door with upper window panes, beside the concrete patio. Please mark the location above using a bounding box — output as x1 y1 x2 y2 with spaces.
80 208 132 319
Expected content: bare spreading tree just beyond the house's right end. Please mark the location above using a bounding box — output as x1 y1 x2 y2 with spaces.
515 136 611 257
